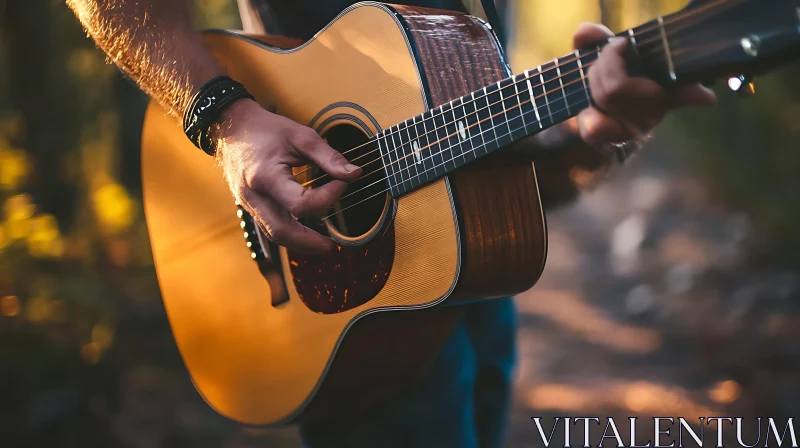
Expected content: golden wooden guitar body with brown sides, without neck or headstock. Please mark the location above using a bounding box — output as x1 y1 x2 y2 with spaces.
142 3 547 426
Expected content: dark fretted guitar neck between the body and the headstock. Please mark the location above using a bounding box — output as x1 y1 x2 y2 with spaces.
376 14 677 197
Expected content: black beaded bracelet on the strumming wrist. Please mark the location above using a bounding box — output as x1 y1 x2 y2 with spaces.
183 76 253 156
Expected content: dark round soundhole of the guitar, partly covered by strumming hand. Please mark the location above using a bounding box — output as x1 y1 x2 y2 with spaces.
313 124 391 245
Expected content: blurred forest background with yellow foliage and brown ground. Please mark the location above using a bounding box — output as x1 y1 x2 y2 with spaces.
0 0 800 448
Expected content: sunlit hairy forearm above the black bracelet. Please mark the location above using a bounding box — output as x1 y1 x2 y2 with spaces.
67 0 223 119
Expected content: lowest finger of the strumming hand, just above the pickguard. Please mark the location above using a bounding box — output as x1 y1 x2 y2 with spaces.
246 188 336 253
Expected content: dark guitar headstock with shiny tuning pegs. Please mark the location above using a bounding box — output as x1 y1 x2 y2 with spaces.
633 0 800 90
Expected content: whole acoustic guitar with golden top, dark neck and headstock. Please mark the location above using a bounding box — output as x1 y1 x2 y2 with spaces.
142 0 800 427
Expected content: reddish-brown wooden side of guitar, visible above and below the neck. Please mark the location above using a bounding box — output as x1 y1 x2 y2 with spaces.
392 5 547 302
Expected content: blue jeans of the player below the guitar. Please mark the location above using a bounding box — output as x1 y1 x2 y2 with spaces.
300 297 516 448
